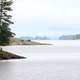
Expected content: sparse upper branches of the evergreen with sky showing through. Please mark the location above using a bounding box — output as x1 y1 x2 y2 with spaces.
0 0 13 24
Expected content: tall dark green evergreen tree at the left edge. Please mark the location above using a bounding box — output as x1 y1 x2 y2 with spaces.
0 0 14 45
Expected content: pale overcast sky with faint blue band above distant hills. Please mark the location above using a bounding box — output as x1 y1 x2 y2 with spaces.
11 0 80 37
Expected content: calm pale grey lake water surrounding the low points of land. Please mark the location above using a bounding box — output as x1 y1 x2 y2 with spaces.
0 41 80 80
